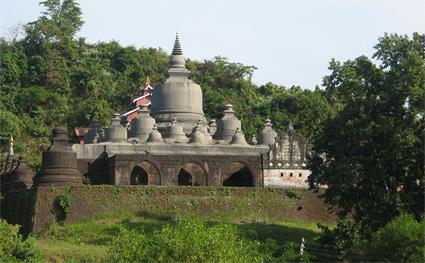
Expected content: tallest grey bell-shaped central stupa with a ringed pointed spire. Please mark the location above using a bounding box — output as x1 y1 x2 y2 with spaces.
151 35 206 134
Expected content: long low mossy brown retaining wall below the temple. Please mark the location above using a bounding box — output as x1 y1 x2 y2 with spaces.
1 185 336 232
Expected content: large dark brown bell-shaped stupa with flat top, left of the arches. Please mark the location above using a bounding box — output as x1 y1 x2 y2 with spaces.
34 128 83 186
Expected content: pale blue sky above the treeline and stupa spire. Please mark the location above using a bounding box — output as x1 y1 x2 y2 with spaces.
0 0 425 89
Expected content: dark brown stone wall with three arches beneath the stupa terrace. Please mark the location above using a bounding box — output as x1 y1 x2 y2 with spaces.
109 154 263 187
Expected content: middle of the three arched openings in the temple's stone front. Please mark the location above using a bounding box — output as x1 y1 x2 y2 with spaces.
177 162 207 186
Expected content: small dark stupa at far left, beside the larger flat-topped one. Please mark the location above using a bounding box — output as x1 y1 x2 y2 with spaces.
8 156 34 191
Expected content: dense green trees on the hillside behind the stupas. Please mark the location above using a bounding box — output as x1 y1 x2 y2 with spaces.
0 0 332 167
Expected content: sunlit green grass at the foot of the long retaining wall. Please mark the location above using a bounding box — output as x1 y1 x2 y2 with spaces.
36 211 319 262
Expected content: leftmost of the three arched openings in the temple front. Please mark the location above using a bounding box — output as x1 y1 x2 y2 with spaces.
130 161 161 185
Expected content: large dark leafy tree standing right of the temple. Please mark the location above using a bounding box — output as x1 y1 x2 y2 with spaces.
309 33 425 230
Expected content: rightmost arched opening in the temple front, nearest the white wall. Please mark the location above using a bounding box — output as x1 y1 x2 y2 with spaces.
222 162 254 187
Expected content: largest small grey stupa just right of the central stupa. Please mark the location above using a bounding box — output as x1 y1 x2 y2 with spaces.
214 104 241 141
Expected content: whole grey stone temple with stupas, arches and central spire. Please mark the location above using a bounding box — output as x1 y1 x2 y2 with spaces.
3 36 310 192
